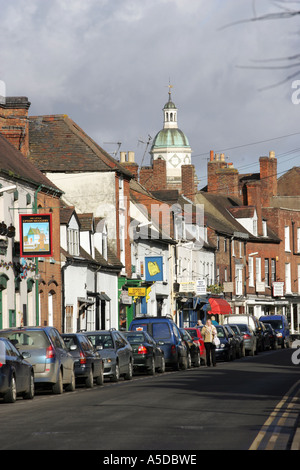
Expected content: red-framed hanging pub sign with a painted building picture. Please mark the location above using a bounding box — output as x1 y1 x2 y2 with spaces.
20 214 52 258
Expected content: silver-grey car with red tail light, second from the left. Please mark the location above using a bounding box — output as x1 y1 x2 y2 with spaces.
0 326 75 394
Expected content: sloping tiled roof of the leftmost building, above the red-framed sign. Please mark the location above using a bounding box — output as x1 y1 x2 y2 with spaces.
0 133 62 193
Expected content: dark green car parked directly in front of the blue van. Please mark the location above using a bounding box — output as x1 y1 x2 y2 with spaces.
123 331 166 375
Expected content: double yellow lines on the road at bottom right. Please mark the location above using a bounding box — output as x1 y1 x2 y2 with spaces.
249 380 300 450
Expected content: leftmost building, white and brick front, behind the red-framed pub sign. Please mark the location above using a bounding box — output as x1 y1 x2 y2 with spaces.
0 129 62 330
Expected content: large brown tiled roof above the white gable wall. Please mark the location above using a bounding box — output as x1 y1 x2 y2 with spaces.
29 114 132 178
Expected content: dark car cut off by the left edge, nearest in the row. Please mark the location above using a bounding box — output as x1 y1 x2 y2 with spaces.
0 338 34 403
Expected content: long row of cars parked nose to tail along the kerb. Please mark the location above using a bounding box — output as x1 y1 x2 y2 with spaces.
0 316 286 403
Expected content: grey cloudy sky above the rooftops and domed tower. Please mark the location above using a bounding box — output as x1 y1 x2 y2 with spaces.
0 0 300 188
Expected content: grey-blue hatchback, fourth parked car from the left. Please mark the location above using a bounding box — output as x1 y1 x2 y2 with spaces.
84 329 133 382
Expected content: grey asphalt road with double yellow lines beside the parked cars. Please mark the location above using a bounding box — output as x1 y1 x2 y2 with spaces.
0 349 300 454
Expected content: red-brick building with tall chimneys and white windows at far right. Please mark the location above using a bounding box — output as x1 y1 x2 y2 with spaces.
203 152 300 331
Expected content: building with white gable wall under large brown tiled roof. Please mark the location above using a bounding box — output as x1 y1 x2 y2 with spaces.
29 115 133 328
